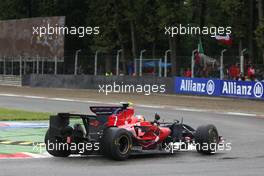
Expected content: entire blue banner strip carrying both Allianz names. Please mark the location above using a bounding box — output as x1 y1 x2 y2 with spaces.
174 77 264 100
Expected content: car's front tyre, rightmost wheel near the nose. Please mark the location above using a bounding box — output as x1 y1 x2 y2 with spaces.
195 125 219 154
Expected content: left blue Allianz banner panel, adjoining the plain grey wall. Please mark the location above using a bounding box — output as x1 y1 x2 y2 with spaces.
174 77 220 96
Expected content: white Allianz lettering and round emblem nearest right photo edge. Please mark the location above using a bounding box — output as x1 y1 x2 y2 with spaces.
222 81 264 98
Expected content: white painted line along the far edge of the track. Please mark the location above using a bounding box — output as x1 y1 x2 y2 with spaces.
0 93 263 117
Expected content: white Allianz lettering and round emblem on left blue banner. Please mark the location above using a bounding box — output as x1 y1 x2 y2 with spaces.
180 79 215 95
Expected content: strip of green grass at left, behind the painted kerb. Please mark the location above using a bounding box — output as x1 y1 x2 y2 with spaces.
0 108 51 121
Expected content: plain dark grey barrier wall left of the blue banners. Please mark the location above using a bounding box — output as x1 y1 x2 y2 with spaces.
22 74 174 93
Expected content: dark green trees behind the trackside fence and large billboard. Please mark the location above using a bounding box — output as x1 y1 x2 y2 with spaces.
0 0 264 75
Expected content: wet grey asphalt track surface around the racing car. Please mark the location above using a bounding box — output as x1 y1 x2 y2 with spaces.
0 96 264 176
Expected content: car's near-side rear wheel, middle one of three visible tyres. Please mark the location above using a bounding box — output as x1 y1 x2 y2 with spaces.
101 127 132 160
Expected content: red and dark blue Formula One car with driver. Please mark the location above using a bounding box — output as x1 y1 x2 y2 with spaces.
45 103 221 160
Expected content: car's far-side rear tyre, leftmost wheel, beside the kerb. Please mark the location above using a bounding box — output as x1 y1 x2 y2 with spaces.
44 129 71 157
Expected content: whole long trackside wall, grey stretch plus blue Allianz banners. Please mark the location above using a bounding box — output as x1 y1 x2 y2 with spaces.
22 74 264 100
